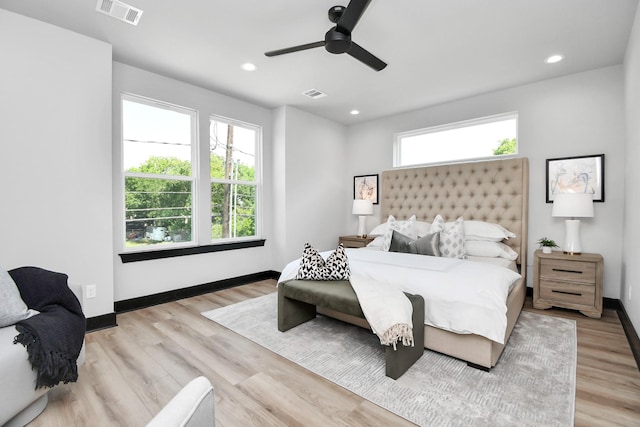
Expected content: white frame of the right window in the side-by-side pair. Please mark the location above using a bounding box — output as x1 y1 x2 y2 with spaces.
207 114 262 244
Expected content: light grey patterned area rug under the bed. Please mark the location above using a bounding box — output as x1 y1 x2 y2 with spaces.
202 293 577 426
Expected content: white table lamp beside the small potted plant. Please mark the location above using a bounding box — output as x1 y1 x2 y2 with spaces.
551 193 593 255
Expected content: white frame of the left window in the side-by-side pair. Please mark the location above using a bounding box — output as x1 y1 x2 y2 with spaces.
120 93 199 253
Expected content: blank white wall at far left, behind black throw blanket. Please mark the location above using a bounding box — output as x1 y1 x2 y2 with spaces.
0 9 113 317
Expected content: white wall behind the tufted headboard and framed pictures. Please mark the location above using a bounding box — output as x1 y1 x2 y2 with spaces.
345 66 625 298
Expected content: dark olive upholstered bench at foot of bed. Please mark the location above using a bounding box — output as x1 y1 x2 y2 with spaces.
278 280 424 379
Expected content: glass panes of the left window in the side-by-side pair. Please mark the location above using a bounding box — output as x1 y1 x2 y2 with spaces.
122 96 197 249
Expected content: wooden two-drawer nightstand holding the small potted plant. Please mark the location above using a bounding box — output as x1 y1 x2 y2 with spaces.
533 249 604 319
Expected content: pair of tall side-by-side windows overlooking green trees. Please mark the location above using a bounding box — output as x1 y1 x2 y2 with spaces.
122 95 264 253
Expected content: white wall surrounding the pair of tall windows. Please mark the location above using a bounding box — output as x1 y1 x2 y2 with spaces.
112 62 273 301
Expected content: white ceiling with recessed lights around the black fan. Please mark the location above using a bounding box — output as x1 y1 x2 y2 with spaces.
0 0 638 124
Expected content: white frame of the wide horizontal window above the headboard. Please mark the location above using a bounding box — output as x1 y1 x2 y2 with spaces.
393 111 518 168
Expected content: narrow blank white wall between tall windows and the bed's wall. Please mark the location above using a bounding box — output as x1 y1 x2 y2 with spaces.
274 106 353 271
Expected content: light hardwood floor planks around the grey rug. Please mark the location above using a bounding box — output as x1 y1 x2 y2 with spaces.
29 281 640 427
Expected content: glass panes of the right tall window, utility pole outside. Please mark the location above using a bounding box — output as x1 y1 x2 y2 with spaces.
209 117 260 240
